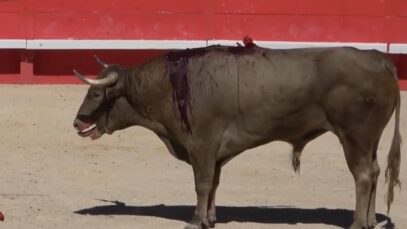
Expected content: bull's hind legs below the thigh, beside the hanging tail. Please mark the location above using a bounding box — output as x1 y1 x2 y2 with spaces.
339 134 380 229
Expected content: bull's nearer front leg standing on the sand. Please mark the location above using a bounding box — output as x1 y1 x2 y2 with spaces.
185 154 216 229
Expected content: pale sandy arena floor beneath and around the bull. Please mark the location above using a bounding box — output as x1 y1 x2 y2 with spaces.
0 85 407 229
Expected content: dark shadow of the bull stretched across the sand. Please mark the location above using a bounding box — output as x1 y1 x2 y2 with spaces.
75 200 394 229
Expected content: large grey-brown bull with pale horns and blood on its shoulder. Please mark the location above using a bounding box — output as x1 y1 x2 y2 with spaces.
74 45 401 229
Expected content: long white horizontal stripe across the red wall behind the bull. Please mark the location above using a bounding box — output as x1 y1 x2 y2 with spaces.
0 39 407 53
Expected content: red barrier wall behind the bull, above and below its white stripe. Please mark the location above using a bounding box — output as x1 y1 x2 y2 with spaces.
0 0 407 85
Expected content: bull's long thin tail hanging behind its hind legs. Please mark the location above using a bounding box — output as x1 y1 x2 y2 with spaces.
386 63 401 214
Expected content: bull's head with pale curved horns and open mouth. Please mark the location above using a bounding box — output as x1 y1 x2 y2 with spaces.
73 56 133 139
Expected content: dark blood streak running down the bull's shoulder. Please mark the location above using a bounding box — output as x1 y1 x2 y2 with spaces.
167 48 208 133
